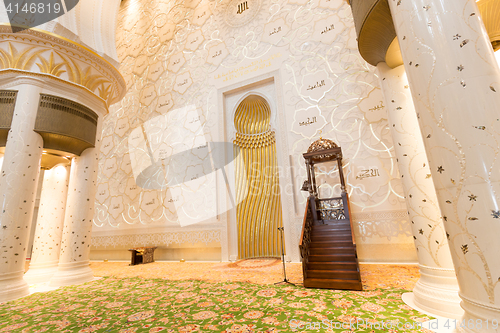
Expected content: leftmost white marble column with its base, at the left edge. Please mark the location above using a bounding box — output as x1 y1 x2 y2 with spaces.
0 84 43 302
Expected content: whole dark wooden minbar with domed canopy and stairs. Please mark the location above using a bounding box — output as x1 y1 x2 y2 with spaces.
299 138 363 290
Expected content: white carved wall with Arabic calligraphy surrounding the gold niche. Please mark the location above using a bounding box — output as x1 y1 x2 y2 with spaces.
93 0 416 261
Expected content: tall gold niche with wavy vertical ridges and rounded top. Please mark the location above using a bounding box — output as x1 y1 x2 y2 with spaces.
233 95 283 259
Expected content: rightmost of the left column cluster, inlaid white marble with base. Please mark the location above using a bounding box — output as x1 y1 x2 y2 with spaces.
50 118 102 287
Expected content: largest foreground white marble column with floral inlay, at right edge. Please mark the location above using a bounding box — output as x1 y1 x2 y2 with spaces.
389 0 500 332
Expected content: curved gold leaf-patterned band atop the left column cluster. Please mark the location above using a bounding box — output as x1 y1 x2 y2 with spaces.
0 25 126 107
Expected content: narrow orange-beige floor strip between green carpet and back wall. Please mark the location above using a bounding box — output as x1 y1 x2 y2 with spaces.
90 259 420 290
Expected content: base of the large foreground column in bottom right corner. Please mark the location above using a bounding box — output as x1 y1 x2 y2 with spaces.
455 294 500 333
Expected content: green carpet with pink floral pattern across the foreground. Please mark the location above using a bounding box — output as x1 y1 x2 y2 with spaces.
0 278 430 333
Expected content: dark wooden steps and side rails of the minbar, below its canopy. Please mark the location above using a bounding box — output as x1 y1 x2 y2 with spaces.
300 195 362 290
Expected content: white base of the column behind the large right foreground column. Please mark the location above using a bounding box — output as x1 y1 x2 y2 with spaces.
403 265 464 319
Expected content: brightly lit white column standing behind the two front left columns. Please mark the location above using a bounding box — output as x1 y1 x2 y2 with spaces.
24 165 70 284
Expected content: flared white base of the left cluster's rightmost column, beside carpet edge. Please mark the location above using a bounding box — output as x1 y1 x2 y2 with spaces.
49 260 94 287
